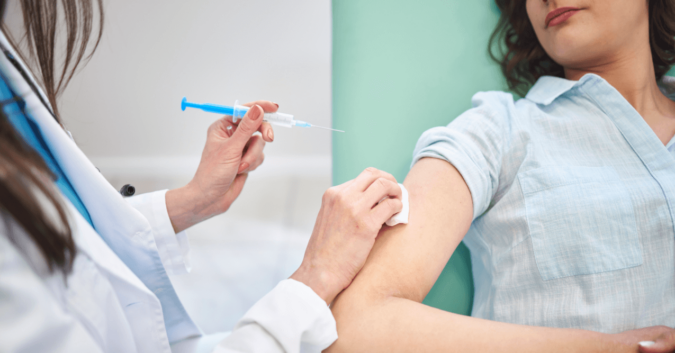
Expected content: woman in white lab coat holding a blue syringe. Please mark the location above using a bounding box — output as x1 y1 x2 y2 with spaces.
0 0 402 353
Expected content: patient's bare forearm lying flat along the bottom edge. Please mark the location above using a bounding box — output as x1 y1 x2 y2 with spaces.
328 296 620 353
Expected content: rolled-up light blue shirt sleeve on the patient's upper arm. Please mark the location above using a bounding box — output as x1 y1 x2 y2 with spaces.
413 92 514 219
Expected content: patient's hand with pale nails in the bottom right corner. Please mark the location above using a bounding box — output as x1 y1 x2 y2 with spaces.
612 326 675 353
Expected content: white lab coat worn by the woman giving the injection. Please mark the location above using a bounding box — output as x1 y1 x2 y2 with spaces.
0 34 337 353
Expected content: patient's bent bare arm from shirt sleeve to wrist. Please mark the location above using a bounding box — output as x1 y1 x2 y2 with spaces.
329 158 637 353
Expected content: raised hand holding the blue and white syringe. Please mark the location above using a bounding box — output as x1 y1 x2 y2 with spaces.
166 101 278 232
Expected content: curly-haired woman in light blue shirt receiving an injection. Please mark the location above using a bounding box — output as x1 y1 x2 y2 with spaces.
330 0 675 353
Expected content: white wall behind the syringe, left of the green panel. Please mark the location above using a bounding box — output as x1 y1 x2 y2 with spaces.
56 0 331 175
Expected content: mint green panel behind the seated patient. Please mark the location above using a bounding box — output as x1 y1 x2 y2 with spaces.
332 0 505 314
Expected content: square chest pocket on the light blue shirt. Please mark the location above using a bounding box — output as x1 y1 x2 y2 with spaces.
518 167 642 281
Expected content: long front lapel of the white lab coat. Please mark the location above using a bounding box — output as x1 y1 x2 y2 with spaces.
0 33 201 342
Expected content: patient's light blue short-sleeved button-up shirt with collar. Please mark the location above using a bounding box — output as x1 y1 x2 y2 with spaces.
413 74 675 333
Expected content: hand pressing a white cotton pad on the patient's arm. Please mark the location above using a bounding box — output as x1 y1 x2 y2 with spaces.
291 168 403 304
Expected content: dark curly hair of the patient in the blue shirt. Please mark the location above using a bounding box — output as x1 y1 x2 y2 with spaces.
489 0 675 96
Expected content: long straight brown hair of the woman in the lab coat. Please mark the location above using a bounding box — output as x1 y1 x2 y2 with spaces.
0 0 103 274
